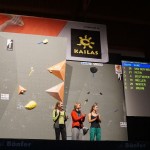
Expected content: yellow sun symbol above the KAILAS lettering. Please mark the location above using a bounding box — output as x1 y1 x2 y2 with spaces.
77 35 95 49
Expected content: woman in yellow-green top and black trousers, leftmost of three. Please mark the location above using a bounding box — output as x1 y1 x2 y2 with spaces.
52 101 68 140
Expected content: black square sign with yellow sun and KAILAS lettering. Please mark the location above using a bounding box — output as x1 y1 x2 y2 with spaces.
71 29 101 59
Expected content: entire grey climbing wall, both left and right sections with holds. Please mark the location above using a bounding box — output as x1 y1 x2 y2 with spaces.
0 32 127 140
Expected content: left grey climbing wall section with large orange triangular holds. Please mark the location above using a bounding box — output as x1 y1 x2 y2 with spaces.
0 32 67 139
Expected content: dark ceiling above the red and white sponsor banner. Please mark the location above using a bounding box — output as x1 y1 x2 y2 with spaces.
0 0 150 55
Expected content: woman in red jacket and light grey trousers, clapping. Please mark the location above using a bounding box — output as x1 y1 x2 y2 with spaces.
71 103 86 140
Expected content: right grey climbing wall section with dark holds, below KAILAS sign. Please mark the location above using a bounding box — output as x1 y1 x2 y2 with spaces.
64 61 127 141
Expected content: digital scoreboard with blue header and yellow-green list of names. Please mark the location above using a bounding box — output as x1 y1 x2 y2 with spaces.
122 61 150 117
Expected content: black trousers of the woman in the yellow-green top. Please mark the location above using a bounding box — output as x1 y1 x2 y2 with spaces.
55 124 67 140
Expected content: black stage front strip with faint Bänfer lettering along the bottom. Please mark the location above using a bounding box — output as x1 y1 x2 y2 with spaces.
0 139 150 150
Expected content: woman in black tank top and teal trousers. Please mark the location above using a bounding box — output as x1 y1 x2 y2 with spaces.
88 103 101 141
